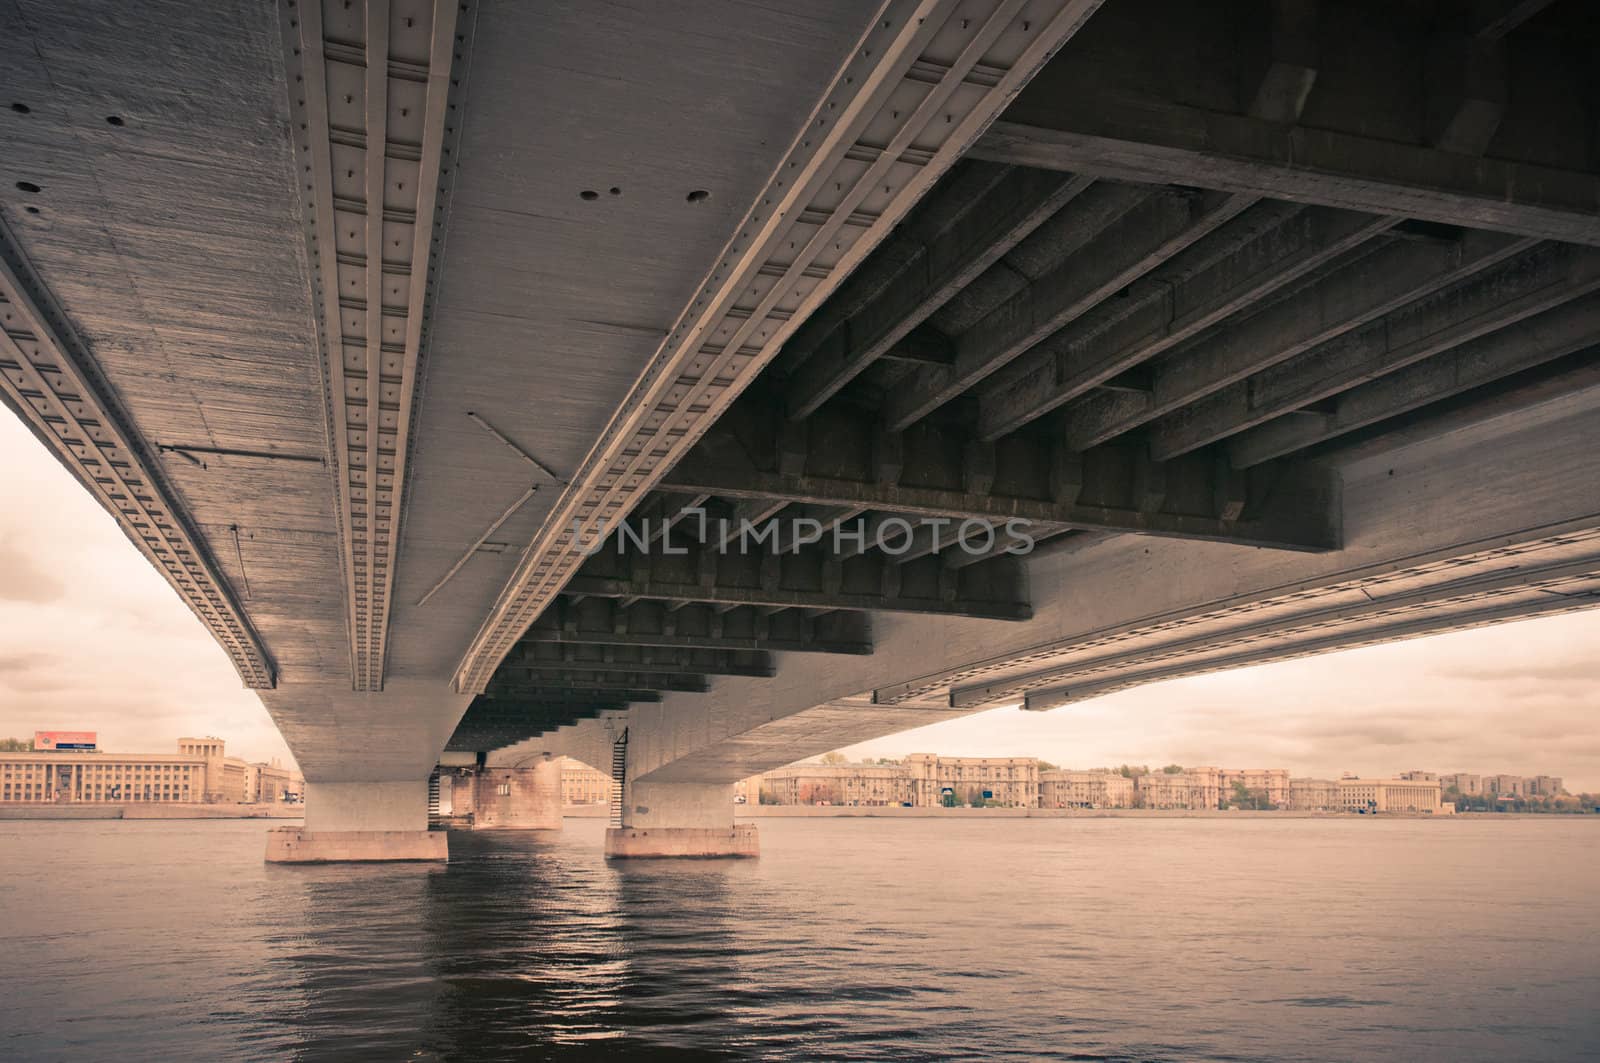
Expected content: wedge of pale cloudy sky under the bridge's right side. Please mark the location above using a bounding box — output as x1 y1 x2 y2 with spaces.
850 610 1600 791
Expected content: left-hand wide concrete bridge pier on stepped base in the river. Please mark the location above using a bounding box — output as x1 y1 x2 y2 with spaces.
267 778 450 863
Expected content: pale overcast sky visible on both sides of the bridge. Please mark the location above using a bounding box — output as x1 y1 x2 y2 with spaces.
0 411 1600 791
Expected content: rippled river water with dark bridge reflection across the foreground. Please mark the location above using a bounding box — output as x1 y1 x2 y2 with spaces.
0 816 1600 1063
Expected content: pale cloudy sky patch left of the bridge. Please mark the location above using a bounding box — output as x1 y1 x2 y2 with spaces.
0 415 290 762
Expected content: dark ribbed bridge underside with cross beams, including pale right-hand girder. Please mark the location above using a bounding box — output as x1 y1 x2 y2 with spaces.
483 0 1600 783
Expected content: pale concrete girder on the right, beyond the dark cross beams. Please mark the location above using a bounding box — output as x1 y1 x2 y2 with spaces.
493 383 1600 784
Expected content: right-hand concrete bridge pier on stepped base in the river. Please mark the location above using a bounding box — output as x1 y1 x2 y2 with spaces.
605 783 762 858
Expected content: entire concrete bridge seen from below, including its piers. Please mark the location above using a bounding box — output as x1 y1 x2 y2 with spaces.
0 0 1600 860
